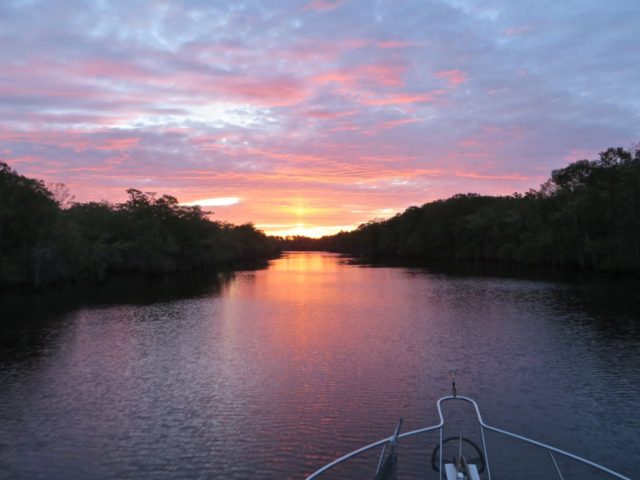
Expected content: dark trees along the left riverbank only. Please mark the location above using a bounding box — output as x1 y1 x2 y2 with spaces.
0 162 279 287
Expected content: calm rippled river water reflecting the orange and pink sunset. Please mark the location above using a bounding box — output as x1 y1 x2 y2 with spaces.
0 253 640 479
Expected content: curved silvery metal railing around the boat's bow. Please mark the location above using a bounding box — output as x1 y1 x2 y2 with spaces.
306 395 631 480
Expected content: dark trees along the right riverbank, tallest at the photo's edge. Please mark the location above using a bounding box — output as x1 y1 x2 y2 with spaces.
281 148 640 272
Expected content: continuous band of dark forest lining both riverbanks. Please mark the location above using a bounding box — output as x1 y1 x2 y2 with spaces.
5 147 640 287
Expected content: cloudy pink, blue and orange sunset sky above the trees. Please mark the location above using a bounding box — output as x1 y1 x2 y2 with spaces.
0 0 640 236
